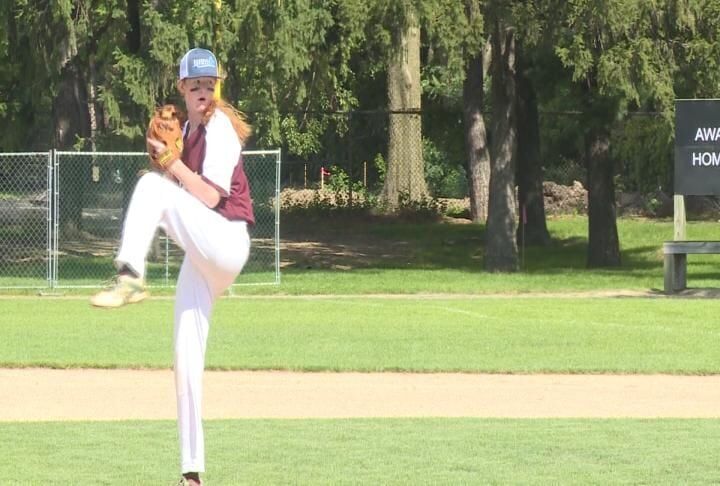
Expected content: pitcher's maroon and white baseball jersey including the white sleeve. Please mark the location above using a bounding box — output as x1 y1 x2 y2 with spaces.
181 109 255 225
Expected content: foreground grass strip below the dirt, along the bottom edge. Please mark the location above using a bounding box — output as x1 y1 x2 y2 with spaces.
0 419 720 486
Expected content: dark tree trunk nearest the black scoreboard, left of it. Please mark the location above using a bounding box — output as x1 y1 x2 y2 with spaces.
585 129 620 267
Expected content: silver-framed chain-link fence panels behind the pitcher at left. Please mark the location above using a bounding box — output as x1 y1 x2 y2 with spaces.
0 150 280 288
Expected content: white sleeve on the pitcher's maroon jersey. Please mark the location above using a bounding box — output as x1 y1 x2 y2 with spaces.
202 110 242 194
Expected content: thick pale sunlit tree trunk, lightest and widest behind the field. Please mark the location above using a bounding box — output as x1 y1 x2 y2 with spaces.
382 9 428 207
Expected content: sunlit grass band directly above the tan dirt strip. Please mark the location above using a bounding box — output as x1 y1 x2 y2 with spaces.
0 296 720 374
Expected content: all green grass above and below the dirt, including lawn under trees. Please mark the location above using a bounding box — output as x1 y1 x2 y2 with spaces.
0 218 720 486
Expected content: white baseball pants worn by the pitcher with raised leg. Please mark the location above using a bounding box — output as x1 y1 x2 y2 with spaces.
115 172 250 473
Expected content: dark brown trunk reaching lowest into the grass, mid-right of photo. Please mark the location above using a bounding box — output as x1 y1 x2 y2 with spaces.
485 19 518 272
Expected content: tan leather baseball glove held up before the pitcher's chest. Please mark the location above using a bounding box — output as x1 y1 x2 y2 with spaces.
146 105 185 171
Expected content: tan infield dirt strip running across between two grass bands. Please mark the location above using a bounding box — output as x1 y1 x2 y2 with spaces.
0 368 720 422
